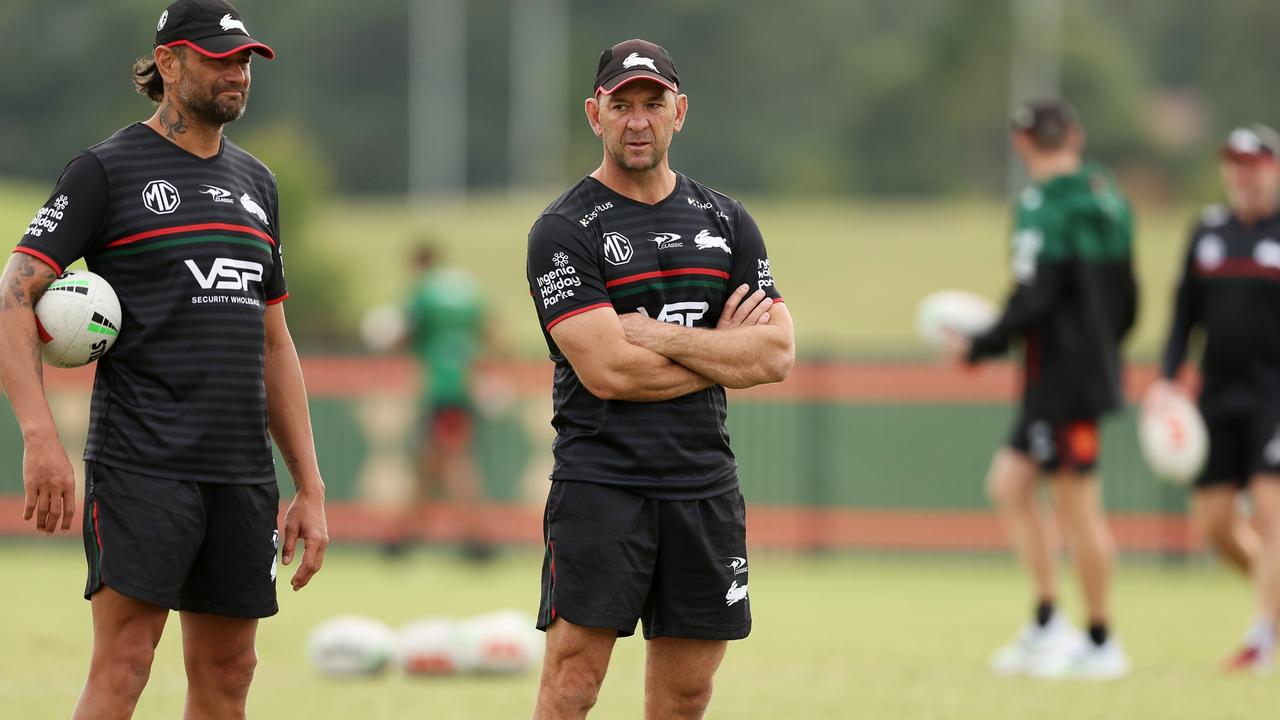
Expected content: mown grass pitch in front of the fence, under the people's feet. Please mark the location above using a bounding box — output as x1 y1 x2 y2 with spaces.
0 541 1280 720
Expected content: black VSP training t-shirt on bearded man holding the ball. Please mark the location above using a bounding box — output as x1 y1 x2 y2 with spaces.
15 123 288 483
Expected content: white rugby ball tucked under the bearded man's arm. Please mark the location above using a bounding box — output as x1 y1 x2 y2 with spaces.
36 270 123 368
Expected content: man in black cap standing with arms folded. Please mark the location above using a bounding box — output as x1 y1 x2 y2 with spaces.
527 40 795 720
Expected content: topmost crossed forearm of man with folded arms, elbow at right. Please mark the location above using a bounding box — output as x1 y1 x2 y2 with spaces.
627 320 794 388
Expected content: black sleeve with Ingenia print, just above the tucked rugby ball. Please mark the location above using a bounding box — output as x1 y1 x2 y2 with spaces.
14 152 109 273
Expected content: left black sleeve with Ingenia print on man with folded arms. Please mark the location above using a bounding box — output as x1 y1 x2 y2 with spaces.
525 214 613 332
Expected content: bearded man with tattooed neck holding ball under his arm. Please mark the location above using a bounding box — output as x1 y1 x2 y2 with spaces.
0 0 328 720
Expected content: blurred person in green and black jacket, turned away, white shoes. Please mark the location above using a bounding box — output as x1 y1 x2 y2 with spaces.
952 100 1137 679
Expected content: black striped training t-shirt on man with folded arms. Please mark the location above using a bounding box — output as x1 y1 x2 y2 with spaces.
526 176 781 500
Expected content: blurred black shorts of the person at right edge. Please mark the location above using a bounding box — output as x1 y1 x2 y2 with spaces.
1196 407 1280 488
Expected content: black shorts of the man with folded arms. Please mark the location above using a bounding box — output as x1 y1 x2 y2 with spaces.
538 480 751 641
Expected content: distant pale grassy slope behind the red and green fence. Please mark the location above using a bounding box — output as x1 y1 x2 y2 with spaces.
0 176 1192 357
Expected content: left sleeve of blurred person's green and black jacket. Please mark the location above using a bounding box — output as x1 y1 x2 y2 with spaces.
969 203 1070 363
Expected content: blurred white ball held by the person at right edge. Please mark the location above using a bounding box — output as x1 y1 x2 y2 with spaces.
1138 387 1208 484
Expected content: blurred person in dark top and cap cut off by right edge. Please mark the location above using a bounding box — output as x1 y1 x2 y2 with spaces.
1152 124 1280 671
